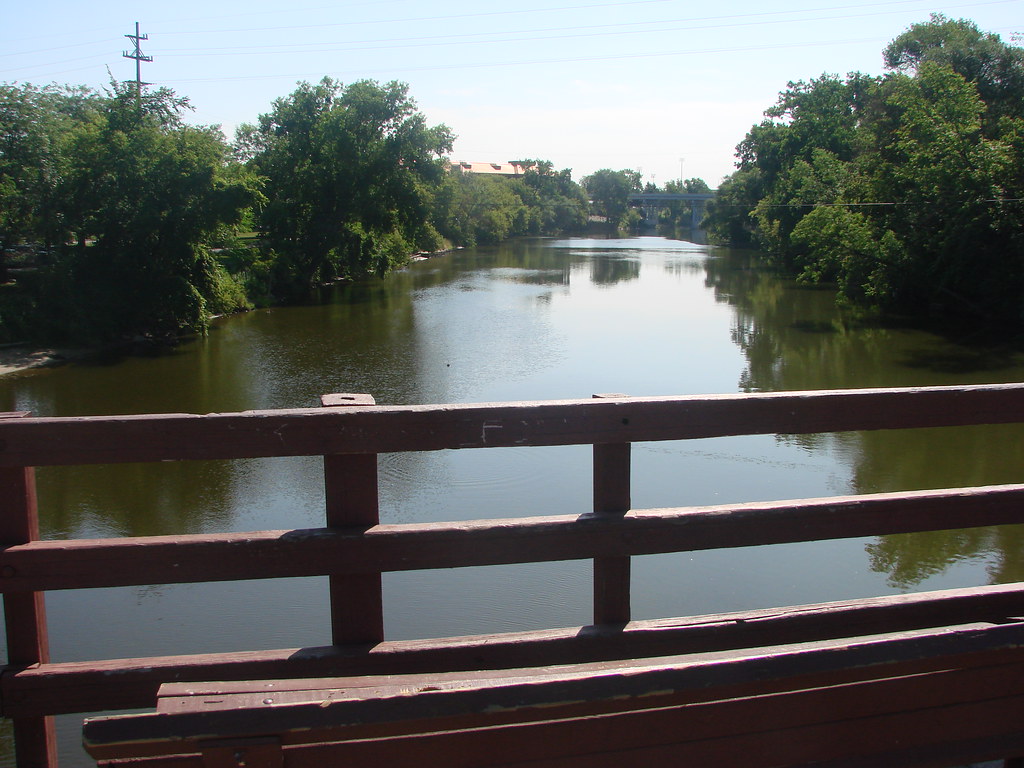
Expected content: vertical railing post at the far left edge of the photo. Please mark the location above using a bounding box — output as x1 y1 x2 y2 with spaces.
0 412 57 768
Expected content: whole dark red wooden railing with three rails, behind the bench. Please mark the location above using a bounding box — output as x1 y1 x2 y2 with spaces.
0 384 1024 768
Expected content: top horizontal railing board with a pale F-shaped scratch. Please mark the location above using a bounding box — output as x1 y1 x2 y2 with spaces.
0 384 1024 466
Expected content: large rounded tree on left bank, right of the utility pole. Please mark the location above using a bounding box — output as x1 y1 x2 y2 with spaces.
237 78 453 289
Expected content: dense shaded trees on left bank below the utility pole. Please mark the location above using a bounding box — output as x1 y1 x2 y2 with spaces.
0 82 259 342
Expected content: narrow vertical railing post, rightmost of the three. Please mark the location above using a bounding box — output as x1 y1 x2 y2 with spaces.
594 394 631 624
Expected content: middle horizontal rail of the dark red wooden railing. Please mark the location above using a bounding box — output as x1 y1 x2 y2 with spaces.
6 485 1024 593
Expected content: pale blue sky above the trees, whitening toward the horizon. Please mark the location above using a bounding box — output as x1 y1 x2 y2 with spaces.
6 0 1024 187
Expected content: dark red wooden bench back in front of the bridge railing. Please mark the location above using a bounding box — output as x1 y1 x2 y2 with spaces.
85 648 1024 768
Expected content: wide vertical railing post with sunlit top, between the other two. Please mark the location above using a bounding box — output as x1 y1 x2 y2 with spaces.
321 394 384 645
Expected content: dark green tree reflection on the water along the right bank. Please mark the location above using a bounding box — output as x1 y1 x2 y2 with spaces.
706 246 1024 589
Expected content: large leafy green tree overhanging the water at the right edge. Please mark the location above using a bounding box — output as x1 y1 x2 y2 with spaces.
782 61 1024 321
